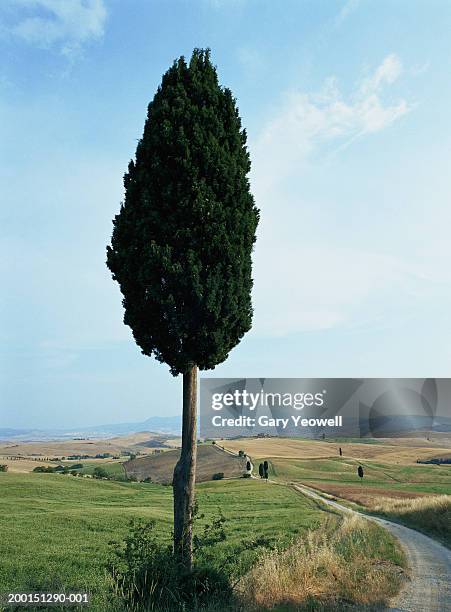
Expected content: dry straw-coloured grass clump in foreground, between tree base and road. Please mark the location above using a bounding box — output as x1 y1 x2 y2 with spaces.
239 515 405 610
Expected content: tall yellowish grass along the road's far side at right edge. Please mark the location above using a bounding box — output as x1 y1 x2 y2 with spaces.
369 495 451 547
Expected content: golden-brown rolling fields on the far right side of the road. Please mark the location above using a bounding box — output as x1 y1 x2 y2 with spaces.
225 437 451 546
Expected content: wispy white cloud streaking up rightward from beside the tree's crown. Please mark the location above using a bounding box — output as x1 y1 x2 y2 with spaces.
252 54 411 192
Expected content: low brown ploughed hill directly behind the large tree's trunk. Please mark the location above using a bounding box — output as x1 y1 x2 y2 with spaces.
124 445 246 484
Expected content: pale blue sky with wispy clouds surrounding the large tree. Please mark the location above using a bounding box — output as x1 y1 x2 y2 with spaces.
0 0 451 428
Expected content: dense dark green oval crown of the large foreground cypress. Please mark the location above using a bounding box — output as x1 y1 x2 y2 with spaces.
107 50 259 375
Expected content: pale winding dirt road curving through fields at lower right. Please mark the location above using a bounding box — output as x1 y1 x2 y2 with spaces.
295 485 451 612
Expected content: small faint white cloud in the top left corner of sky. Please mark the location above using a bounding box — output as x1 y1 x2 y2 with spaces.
3 0 106 56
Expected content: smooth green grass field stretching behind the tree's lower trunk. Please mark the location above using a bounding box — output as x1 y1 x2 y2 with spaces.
0 473 322 610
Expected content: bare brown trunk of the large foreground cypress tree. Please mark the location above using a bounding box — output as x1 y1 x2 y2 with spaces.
173 366 197 570
